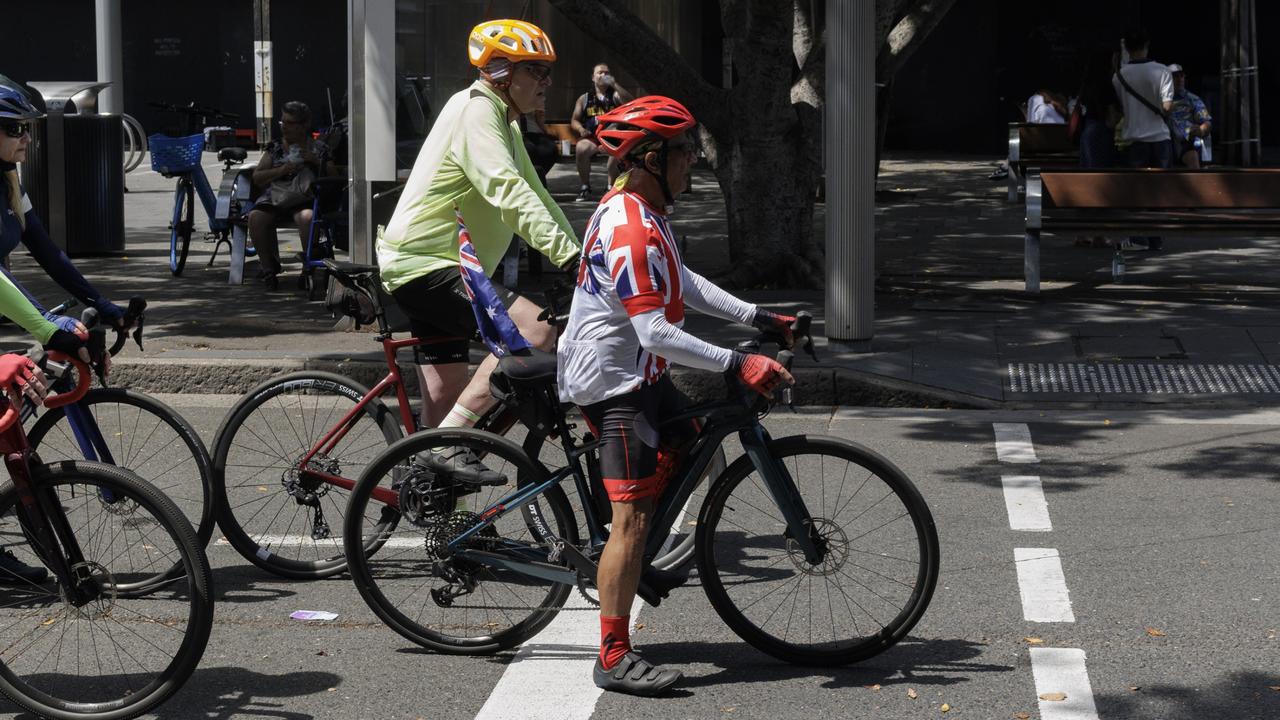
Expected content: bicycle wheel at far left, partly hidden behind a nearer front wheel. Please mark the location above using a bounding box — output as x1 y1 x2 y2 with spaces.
27 387 215 547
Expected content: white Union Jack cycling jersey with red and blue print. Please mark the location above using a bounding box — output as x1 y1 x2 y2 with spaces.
557 190 755 405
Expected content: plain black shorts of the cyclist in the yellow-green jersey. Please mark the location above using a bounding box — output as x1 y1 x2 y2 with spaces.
392 266 518 365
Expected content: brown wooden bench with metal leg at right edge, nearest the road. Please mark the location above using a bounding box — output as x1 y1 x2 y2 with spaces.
1023 168 1280 293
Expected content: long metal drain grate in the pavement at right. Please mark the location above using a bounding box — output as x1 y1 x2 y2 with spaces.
1009 363 1280 395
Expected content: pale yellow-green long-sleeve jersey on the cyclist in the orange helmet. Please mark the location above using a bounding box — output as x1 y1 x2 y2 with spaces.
378 81 580 292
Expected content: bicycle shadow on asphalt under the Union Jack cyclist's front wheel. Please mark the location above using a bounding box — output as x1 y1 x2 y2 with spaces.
644 638 998 689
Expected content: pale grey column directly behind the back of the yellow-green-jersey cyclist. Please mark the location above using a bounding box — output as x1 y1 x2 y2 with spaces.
347 0 396 263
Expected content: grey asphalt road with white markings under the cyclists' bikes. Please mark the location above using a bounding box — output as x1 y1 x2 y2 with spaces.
0 396 1280 720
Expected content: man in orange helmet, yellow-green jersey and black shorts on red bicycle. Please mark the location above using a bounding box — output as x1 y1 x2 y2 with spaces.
376 19 579 484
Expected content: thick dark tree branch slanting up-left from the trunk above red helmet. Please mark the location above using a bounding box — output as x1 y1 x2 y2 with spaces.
550 0 731 129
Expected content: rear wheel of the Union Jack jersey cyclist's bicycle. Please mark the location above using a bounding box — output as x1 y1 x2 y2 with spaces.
344 428 577 655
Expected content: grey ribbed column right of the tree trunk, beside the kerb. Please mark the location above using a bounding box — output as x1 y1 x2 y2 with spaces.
823 0 876 347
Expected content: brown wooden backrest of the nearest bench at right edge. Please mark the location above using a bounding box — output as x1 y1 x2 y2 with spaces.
1041 168 1280 210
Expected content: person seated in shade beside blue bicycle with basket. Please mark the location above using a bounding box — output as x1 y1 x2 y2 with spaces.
248 100 335 290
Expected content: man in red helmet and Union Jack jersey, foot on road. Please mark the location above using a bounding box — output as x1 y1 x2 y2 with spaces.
557 96 795 696
